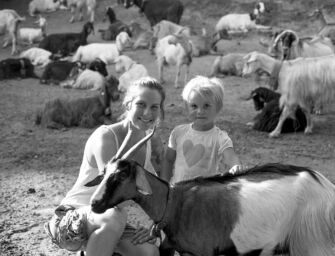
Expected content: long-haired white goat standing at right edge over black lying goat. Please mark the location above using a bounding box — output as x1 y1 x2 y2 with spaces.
243 52 335 137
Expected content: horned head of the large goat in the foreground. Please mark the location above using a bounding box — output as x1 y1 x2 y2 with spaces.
85 128 155 213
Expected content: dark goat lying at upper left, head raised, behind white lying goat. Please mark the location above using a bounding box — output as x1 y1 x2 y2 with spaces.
38 22 94 56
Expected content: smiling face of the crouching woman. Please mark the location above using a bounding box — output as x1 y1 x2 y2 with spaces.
128 88 162 130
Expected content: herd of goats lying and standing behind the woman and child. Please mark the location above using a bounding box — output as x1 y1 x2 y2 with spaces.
0 0 335 137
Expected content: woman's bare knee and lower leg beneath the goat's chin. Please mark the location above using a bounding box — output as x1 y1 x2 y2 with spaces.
86 208 128 256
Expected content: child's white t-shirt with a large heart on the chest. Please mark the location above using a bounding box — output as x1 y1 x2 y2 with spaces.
169 124 233 184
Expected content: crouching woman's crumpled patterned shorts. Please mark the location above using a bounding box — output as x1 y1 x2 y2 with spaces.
44 205 136 252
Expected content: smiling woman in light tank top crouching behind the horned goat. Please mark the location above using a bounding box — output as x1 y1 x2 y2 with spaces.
45 77 165 256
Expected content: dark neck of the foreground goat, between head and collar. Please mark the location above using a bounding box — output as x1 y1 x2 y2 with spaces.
134 173 170 223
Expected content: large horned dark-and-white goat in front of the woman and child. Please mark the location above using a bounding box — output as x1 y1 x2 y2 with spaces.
85 129 335 256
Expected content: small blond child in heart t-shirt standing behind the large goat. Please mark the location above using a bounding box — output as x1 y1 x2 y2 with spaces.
161 76 243 184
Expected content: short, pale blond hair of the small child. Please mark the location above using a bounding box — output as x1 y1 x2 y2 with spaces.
182 76 224 112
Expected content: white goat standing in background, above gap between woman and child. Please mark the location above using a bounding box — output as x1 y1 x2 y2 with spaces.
155 35 192 88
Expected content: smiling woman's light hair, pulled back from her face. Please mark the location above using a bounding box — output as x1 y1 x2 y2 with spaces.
123 76 165 120
